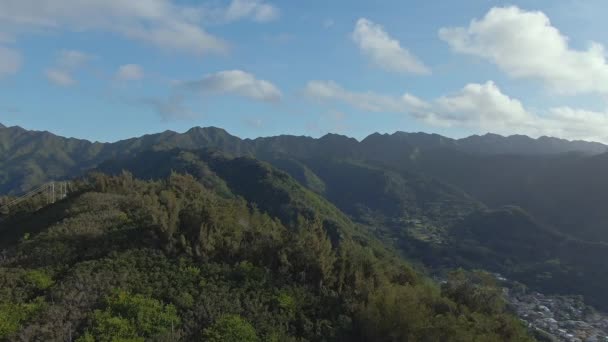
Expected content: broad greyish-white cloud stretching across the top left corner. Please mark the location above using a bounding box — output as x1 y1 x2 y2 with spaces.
0 0 228 54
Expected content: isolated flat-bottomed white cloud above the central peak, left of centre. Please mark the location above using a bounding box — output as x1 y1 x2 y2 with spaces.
180 70 282 102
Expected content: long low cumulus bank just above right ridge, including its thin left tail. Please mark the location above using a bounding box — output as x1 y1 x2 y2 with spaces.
305 81 608 142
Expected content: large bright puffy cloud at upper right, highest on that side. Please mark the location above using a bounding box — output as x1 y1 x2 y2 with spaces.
439 7 608 94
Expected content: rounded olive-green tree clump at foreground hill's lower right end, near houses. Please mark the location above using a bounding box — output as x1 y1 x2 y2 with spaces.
358 285 532 342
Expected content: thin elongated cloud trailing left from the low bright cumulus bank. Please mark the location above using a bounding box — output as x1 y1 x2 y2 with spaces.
304 81 428 112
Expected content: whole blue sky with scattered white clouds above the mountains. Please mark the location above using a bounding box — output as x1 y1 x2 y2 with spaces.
0 0 608 143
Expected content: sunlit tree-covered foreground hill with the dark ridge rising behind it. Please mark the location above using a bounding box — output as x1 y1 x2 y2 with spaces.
0 160 531 341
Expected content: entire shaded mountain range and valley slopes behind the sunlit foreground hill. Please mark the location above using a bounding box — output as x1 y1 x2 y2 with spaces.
0 123 608 309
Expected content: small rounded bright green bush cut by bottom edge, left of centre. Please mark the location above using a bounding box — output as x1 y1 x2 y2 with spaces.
203 315 259 342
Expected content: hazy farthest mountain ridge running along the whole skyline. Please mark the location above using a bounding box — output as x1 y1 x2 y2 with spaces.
0 126 607 193
